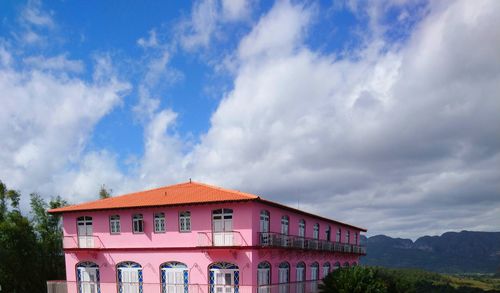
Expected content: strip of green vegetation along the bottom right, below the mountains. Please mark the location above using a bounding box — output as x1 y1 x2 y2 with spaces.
320 266 500 293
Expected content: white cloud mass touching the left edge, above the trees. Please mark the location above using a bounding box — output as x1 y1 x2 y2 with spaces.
0 50 129 204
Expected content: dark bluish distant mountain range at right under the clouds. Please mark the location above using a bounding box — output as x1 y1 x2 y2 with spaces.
361 231 500 273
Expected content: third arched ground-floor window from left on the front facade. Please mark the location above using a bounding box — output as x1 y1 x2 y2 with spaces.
160 261 189 293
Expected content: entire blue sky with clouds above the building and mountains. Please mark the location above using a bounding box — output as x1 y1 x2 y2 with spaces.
0 0 500 239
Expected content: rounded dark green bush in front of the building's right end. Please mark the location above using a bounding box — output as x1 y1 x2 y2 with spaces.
319 266 387 293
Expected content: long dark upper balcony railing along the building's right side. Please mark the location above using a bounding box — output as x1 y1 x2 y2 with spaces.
259 232 366 255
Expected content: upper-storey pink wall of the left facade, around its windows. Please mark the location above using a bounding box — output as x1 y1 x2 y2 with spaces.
63 203 253 248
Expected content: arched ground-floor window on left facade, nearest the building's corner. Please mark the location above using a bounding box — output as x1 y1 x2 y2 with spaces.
208 262 240 293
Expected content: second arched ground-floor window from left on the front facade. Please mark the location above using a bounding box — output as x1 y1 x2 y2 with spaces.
116 261 142 293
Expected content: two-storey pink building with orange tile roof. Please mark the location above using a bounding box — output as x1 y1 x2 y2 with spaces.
50 182 366 293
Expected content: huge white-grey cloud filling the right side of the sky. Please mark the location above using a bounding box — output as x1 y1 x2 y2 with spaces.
181 1 500 236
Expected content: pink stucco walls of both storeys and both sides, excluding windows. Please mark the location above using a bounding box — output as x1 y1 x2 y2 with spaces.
63 202 359 292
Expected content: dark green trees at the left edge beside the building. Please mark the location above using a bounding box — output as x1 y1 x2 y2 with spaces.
0 181 67 293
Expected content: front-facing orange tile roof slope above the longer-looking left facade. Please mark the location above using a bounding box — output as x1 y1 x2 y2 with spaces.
49 182 259 213
